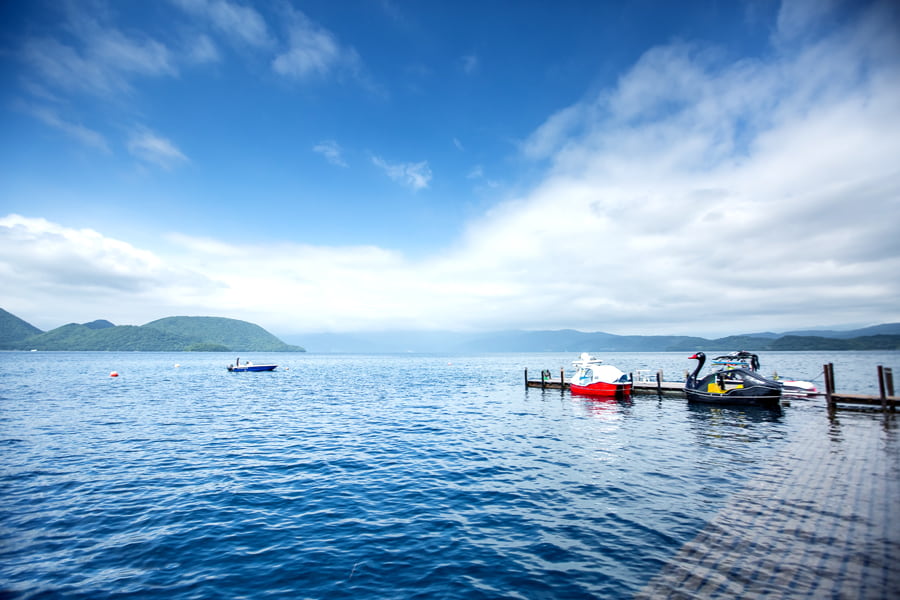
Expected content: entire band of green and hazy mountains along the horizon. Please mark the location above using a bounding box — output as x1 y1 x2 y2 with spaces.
0 309 900 353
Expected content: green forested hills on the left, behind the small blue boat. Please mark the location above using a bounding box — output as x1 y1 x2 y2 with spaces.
0 309 305 352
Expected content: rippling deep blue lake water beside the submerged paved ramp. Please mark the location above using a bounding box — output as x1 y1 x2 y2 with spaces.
0 352 900 599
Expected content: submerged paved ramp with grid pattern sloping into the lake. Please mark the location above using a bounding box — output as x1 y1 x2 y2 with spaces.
636 413 900 600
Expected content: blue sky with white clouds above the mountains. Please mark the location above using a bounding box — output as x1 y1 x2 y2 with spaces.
0 0 900 337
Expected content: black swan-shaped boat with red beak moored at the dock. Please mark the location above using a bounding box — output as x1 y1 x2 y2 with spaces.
684 352 782 407
